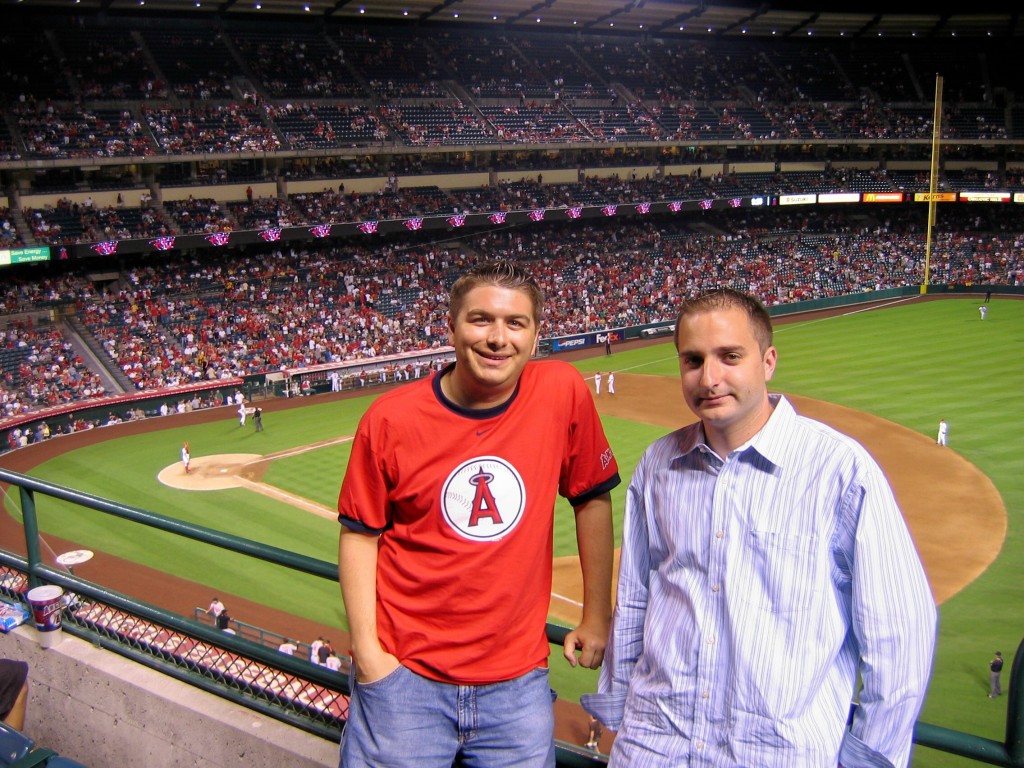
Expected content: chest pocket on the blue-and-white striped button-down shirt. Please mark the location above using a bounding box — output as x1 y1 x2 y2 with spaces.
733 530 819 614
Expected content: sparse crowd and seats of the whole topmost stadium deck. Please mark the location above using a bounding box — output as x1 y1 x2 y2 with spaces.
0 21 1021 159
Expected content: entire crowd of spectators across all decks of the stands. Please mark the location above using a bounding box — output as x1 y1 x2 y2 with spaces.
0 20 1024 437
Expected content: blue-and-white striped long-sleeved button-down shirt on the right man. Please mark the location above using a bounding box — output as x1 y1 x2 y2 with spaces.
583 395 936 768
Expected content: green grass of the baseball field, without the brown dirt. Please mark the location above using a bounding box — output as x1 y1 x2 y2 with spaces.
8 298 1024 768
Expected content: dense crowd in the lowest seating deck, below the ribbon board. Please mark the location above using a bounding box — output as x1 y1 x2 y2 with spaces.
0 201 1024 430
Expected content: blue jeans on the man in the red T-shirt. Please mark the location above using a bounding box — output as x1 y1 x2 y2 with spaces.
341 667 555 768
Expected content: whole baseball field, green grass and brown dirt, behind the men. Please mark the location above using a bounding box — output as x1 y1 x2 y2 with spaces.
0 297 1024 768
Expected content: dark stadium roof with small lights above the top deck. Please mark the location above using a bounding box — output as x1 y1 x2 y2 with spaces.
8 0 1024 38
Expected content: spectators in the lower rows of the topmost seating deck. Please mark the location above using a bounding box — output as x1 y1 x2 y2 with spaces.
9 86 1014 159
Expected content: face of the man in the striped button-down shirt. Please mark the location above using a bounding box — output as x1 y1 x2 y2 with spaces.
676 306 776 457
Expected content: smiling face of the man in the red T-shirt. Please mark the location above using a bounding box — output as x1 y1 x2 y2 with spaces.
441 284 540 409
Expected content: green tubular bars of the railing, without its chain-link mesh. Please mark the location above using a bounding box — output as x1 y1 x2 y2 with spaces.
0 469 1024 768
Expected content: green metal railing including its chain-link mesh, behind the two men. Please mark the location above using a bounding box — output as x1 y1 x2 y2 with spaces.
0 469 1024 768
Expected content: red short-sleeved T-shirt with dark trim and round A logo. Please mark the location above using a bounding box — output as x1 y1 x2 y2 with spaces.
338 360 620 685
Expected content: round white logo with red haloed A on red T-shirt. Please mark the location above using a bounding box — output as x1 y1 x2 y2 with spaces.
440 456 526 542
